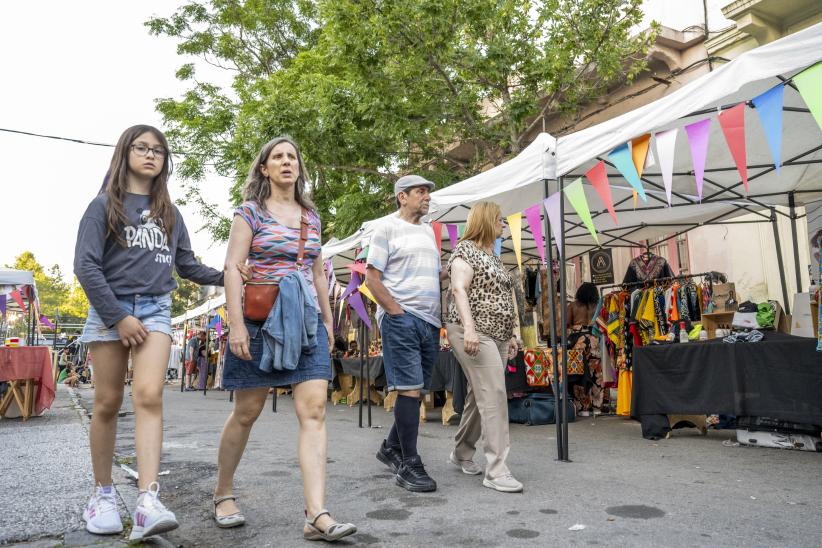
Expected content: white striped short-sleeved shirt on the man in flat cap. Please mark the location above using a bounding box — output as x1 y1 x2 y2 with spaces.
367 213 442 327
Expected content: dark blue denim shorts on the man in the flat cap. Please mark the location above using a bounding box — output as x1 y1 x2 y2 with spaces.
380 312 440 392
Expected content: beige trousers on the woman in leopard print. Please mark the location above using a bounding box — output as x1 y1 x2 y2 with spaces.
445 323 511 479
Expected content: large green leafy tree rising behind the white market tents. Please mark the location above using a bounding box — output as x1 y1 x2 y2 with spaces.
146 0 655 238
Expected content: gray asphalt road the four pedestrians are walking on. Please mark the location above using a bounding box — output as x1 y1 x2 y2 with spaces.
0 386 822 547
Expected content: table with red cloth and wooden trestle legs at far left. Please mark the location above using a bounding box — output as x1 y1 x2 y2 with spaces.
0 346 55 420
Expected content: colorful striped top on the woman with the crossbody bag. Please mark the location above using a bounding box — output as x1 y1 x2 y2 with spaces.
234 202 322 299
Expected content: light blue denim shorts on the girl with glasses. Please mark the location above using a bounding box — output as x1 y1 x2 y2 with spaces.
80 293 171 343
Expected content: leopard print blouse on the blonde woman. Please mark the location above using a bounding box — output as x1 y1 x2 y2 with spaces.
447 240 514 341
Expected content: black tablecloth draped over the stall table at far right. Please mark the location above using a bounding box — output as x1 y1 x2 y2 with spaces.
631 332 822 424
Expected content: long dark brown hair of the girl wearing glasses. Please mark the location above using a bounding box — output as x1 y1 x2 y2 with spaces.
100 124 176 247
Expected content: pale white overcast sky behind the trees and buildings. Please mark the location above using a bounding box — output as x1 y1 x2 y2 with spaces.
0 0 729 279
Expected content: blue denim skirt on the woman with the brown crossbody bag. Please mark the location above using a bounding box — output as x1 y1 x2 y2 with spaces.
223 314 331 390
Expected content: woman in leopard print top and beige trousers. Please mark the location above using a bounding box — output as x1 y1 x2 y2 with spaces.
445 202 522 493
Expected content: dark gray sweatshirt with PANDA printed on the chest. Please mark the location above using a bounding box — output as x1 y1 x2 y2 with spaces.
74 194 223 327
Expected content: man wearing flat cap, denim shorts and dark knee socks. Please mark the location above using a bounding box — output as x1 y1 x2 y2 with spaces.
366 175 442 492
